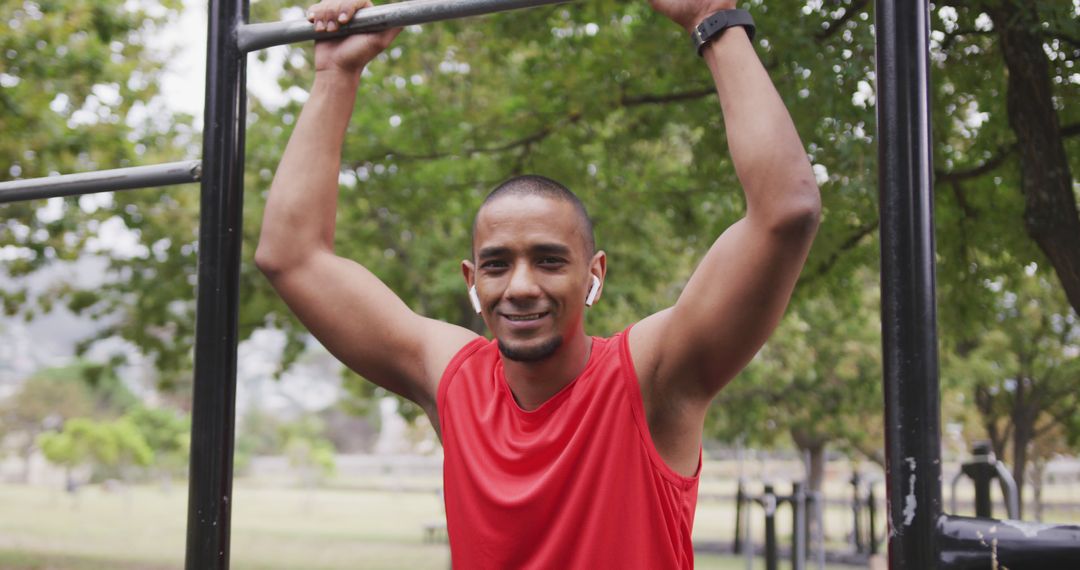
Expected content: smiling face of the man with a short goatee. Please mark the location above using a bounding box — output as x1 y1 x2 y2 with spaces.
464 195 603 362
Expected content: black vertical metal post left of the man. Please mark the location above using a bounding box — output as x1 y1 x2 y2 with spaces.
186 0 247 570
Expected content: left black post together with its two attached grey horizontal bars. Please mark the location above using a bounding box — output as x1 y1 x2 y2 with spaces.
0 0 571 570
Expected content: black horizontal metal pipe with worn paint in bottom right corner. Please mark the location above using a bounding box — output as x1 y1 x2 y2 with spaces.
937 515 1080 570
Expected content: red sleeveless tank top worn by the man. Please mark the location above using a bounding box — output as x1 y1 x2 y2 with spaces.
437 331 700 570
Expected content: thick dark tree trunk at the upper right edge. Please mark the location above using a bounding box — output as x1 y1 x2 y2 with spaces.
984 0 1080 313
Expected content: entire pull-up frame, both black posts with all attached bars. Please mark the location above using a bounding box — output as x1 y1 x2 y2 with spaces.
0 0 1080 570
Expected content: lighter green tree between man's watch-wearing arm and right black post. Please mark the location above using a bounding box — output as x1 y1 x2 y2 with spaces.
707 272 883 491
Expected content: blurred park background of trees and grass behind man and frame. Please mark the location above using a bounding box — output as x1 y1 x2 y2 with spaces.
0 0 1080 569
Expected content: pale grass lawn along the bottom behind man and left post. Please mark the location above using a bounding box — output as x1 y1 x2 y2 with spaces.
0 480 859 570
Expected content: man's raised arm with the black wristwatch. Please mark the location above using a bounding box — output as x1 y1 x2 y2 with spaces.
631 0 821 470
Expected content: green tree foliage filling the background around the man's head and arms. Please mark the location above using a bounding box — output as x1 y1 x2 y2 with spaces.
0 0 1080 457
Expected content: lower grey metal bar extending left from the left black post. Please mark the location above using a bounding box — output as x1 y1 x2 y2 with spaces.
0 161 202 204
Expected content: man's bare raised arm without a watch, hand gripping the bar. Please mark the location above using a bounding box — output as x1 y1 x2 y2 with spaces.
255 0 476 418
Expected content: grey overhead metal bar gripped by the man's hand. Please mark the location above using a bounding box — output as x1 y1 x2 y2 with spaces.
237 0 572 53
